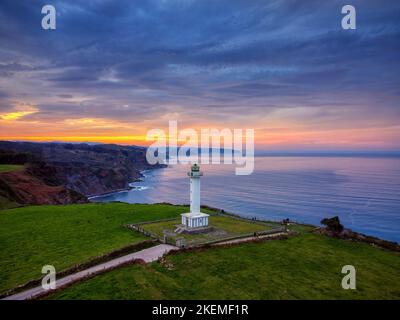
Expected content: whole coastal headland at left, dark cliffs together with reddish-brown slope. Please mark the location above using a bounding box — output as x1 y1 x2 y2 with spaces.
0 141 164 208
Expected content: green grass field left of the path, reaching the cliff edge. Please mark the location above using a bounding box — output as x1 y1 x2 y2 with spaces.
0 203 188 292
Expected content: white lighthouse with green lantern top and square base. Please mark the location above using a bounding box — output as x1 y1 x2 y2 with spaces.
181 164 209 229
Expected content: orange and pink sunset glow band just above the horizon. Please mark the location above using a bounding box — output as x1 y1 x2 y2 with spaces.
0 111 400 149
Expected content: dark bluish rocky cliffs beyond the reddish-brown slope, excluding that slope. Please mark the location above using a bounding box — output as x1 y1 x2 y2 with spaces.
0 141 164 203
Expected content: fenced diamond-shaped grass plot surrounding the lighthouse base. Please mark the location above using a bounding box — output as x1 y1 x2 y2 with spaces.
142 215 276 245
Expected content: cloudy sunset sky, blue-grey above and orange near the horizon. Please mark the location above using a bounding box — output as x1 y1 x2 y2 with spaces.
0 0 400 151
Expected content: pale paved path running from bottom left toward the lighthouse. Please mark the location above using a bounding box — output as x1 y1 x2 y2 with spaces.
3 244 178 300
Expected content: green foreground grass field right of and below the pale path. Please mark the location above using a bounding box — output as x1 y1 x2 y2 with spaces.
49 234 400 299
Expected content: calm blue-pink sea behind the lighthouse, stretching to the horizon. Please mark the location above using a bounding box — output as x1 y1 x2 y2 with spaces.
91 156 400 242
